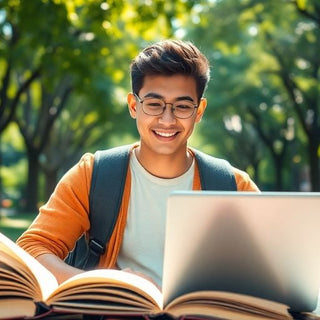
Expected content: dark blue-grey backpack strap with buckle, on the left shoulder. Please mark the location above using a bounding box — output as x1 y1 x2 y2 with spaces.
86 145 131 268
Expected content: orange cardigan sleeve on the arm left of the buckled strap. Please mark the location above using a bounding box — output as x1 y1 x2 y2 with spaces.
17 153 94 259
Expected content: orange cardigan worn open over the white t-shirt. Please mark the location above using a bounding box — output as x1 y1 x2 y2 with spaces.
17 147 259 268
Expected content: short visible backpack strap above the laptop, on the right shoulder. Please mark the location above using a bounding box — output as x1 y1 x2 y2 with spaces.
192 149 237 191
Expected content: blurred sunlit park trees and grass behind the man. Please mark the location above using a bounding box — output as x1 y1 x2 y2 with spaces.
0 0 320 238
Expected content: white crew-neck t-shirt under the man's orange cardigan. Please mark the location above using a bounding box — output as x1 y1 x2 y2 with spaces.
117 152 194 285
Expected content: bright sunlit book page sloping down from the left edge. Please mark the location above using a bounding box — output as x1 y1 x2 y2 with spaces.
0 233 58 298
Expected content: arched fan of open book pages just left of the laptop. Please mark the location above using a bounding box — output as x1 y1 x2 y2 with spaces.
47 269 162 310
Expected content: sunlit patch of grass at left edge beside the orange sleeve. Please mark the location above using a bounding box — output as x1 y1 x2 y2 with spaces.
0 213 36 241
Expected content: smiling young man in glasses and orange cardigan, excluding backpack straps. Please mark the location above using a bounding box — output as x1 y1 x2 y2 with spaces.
18 40 258 285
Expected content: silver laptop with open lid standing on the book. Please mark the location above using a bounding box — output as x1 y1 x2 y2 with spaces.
163 191 320 311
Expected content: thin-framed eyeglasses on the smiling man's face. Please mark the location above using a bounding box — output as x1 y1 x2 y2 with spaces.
134 93 198 119
